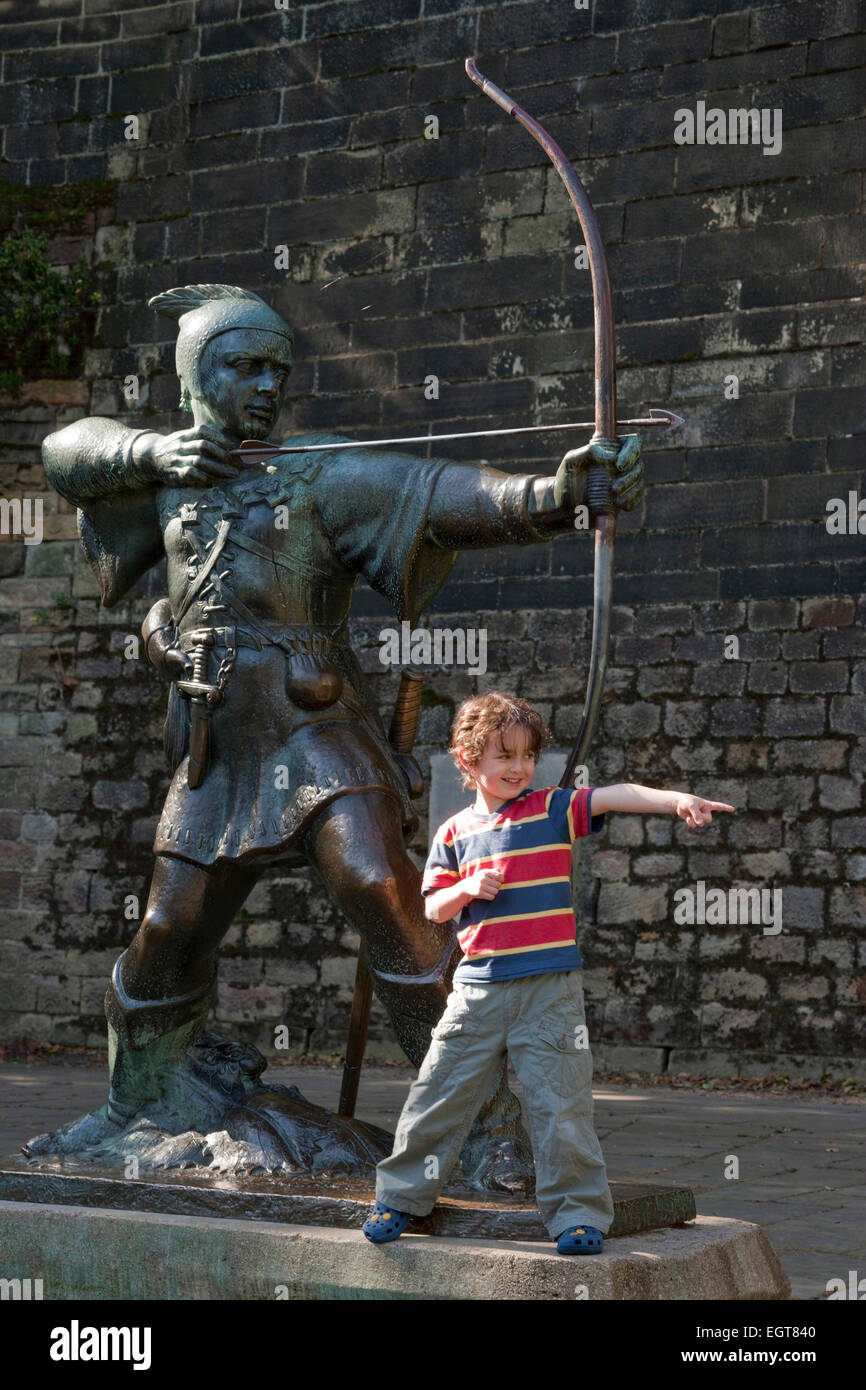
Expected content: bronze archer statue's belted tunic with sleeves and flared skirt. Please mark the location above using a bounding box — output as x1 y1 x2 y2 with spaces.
44 420 570 865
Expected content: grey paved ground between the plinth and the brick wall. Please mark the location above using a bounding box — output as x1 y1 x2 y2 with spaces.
0 1063 866 1300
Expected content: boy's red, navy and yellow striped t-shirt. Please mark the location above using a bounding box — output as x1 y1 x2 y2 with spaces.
421 787 605 981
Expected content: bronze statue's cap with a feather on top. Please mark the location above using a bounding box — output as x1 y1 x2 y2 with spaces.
147 285 295 409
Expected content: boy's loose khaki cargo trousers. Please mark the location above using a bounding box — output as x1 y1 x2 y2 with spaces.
375 970 613 1240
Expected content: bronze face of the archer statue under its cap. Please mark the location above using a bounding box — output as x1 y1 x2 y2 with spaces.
192 328 292 439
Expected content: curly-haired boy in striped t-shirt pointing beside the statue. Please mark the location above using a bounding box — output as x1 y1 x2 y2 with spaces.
363 692 734 1255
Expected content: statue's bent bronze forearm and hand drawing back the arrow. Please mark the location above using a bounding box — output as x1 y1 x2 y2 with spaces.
42 416 240 503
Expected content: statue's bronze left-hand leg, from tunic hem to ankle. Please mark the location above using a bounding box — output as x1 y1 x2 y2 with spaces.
106 855 259 1123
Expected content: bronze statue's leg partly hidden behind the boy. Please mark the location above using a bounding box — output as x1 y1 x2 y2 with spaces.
306 791 532 1191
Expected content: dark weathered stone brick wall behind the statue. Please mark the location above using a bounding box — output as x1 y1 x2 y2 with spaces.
0 0 866 1076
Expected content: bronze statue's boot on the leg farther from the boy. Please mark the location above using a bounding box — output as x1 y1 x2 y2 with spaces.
106 956 215 1126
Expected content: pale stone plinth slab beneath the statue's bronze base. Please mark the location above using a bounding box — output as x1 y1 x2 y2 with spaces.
0 1201 790 1304
